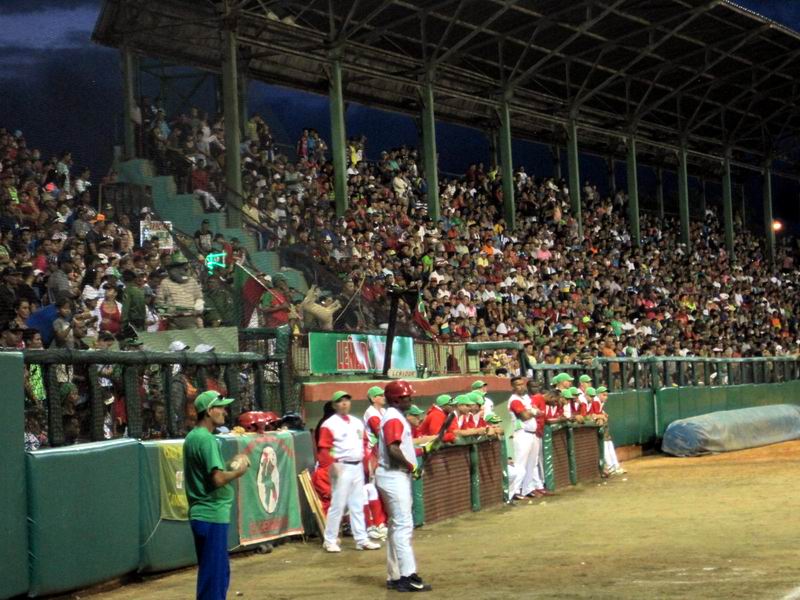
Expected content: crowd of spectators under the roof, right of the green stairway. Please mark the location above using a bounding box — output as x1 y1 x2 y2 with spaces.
147 106 800 374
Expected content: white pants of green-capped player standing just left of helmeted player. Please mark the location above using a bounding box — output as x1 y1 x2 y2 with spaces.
325 463 369 544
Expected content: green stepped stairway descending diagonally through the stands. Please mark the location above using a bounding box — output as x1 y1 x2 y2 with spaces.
117 159 308 292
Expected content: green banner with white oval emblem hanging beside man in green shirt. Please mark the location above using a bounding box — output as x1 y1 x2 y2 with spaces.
238 432 303 546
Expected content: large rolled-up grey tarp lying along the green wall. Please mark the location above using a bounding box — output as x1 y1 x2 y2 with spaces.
661 404 800 456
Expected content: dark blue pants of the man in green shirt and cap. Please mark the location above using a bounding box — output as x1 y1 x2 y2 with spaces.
189 520 231 600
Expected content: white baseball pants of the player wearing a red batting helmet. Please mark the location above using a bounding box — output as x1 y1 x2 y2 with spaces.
375 467 417 580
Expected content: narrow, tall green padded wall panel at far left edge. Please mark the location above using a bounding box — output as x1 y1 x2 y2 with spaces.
0 352 28 598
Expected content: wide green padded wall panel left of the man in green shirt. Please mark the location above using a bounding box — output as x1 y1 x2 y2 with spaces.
25 440 140 597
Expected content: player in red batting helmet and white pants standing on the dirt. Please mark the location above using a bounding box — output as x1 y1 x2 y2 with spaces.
375 380 431 592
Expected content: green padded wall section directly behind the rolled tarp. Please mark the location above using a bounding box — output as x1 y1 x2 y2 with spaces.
652 381 800 442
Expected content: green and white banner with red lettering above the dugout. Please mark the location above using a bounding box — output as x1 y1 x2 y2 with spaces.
308 332 417 377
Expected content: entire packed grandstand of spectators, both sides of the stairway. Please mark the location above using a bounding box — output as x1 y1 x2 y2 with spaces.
0 105 800 448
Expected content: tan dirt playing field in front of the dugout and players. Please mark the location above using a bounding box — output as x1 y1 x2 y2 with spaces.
93 441 800 600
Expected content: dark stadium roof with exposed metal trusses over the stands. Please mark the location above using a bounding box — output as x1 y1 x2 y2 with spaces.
93 0 800 176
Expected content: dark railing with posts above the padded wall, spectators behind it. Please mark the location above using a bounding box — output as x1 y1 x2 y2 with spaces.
22 349 284 446
